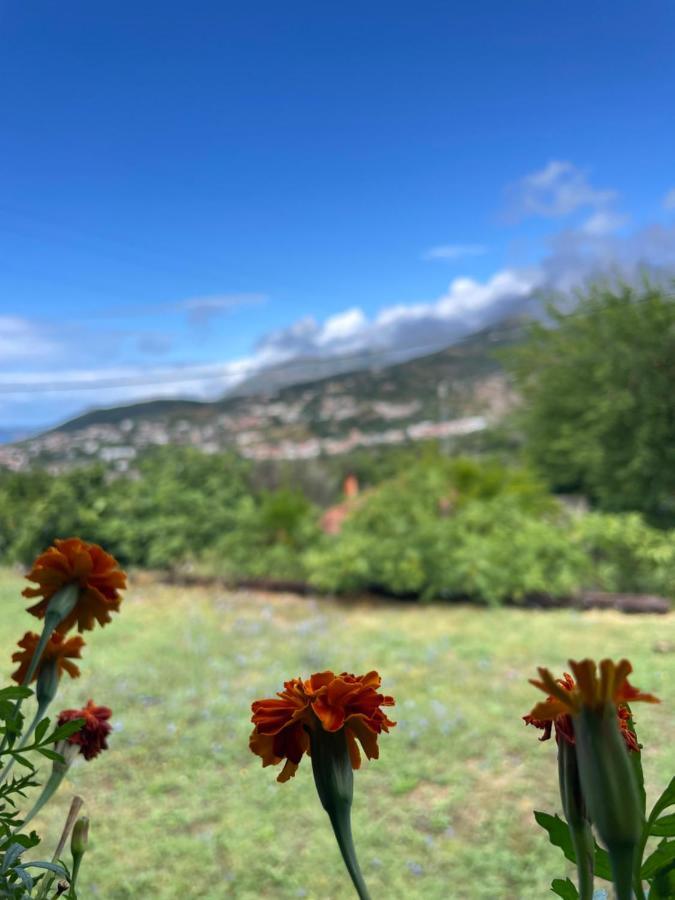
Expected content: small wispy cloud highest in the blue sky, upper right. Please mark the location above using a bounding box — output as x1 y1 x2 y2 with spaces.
507 160 617 220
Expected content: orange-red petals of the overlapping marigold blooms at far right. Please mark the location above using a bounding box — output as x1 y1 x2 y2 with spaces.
523 659 660 751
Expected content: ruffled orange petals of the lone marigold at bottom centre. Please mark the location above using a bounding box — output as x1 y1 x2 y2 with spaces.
249 671 396 781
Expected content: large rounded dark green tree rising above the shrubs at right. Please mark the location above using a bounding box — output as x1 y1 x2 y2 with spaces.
512 280 675 524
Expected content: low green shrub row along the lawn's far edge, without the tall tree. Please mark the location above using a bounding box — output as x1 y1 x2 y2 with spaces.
0 447 675 603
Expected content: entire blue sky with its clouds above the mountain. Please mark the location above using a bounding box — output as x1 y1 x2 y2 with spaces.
0 0 675 427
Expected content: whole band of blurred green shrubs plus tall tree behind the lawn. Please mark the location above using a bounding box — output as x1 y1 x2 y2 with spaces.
0 282 675 604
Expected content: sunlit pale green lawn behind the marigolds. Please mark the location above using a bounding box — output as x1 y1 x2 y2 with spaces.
0 572 675 900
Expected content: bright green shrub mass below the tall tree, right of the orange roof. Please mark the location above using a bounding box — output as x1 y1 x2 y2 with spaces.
305 460 675 604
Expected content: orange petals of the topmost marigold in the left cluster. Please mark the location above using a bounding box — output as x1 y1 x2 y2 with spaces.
23 538 127 634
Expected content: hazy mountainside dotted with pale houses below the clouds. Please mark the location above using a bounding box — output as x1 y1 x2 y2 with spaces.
0 317 526 471
